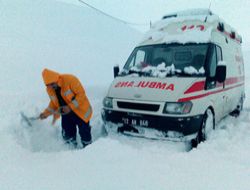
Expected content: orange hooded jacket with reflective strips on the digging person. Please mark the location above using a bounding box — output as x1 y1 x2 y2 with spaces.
42 69 92 123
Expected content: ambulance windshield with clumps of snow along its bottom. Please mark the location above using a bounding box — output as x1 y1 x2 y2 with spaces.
121 44 209 77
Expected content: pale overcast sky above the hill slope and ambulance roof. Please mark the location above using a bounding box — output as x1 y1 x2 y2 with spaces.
61 0 250 42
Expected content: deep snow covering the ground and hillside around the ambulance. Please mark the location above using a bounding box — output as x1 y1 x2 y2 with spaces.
0 0 250 190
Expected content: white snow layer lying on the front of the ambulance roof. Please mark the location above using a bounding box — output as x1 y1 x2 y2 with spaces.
141 9 221 44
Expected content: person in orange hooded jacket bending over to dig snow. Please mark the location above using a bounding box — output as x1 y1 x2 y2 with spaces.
39 69 92 147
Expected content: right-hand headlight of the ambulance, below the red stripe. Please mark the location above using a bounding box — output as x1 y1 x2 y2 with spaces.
163 102 193 114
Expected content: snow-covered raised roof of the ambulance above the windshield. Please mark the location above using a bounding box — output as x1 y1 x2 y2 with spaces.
139 9 242 46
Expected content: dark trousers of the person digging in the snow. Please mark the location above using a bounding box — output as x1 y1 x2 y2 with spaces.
62 111 92 147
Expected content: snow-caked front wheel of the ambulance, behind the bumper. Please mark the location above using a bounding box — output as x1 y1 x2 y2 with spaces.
191 109 215 148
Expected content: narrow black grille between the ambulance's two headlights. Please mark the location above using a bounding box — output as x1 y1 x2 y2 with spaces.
117 101 160 111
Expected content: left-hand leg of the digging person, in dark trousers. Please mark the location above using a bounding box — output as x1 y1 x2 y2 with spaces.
62 114 77 146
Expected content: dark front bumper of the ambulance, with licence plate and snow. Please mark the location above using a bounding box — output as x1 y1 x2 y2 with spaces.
102 109 203 141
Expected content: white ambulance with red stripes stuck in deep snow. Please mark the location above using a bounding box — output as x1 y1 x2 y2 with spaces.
102 9 245 146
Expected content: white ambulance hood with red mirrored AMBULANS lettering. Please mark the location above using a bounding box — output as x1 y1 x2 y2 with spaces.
108 76 197 102
